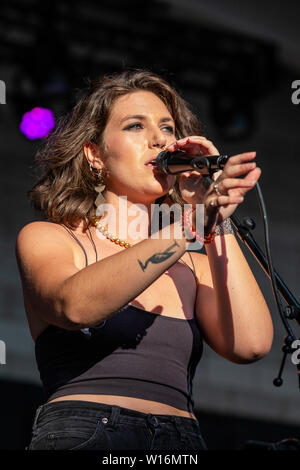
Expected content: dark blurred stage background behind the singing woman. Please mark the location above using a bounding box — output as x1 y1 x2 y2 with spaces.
0 0 300 449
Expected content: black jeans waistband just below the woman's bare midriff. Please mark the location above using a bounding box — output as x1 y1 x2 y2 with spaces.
33 400 199 431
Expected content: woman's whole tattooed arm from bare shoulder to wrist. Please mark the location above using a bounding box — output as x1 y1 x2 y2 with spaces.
16 218 186 330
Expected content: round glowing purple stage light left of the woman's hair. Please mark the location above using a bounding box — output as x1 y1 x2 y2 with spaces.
20 107 55 140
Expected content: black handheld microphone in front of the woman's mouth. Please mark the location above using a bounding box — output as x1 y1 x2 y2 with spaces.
155 150 230 176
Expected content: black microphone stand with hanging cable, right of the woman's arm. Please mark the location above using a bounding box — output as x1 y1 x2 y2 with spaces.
204 166 300 388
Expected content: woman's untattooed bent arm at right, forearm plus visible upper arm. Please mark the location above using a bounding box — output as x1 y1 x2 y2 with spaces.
196 234 273 364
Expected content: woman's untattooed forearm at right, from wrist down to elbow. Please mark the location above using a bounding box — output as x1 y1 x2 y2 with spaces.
205 233 273 362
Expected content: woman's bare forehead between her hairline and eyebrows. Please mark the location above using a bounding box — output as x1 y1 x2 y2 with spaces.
110 90 172 119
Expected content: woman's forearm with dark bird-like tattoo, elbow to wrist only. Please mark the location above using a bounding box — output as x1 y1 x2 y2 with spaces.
61 222 186 328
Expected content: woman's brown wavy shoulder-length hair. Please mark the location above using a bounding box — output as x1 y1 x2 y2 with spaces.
27 69 203 232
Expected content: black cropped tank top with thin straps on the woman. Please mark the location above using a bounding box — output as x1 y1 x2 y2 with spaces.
35 227 203 412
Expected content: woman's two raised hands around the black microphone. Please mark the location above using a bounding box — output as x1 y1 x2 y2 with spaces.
158 136 261 224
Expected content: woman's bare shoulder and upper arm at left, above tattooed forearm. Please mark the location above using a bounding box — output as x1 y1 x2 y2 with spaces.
15 221 78 338
